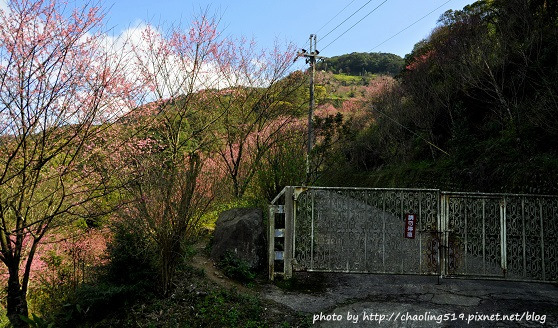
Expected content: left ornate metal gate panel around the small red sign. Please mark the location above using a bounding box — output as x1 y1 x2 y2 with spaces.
294 188 438 274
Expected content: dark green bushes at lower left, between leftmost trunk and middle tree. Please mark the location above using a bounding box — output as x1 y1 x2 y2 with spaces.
40 222 159 327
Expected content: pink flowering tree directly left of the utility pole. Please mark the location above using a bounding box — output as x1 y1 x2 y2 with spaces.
217 39 305 198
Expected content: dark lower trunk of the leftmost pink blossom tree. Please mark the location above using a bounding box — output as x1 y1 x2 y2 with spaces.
7 265 29 328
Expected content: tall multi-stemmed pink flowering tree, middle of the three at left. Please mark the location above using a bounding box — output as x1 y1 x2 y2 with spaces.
120 14 223 294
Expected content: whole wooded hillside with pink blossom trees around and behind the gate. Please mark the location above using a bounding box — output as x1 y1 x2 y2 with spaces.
0 0 558 327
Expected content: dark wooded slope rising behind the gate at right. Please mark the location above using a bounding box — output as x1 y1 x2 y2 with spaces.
327 0 558 194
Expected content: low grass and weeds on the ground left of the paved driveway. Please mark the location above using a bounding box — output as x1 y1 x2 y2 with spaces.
78 247 311 328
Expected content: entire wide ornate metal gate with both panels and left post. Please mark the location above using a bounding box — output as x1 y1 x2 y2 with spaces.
268 187 558 281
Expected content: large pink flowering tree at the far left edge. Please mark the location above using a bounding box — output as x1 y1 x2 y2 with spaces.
0 0 133 327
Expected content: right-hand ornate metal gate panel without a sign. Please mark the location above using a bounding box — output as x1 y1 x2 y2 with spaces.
442 192 558 281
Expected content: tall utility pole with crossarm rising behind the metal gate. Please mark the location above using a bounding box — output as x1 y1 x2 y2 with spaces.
297 34 323 184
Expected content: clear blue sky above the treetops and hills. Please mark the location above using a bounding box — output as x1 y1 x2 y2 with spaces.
104 0 480 57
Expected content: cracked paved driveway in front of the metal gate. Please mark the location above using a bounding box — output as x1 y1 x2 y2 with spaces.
263 273 558 327
